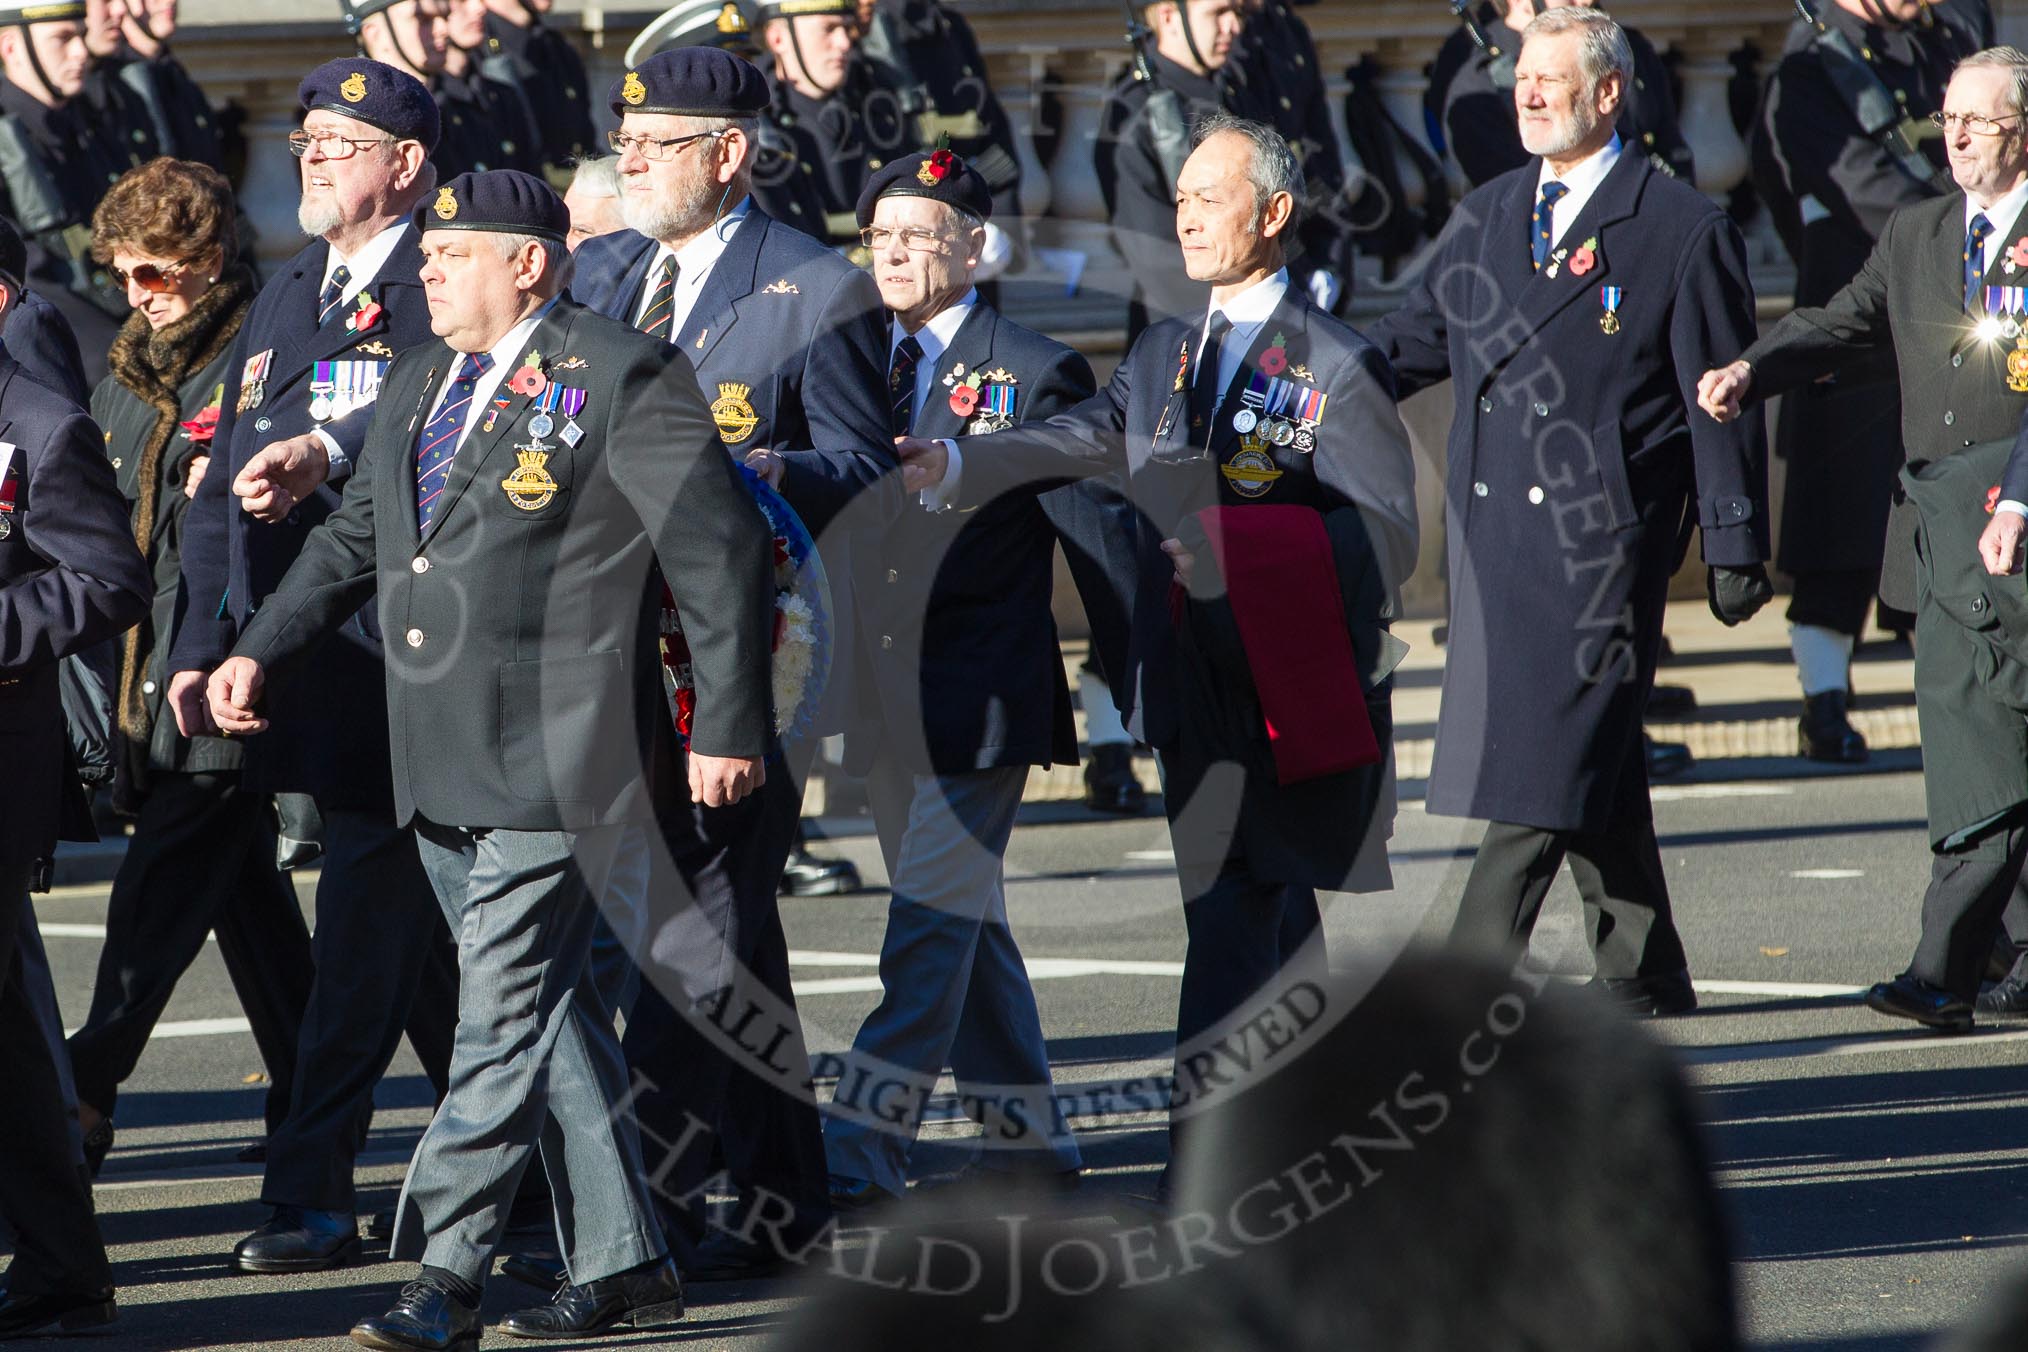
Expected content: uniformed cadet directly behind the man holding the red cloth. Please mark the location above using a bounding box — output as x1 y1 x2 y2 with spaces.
1091 0 1241 343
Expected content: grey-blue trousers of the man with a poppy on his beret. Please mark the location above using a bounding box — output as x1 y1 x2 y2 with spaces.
823 762 1081 1194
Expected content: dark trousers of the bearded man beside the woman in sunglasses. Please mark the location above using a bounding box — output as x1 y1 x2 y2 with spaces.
262 809 458 1212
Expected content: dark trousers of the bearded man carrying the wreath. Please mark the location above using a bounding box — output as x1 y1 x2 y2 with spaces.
621 742 831 1261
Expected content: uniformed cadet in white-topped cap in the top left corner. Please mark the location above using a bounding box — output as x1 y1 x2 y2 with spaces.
0 0 156 385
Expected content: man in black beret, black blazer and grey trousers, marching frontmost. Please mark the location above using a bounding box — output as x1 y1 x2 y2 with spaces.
209 170 773 1350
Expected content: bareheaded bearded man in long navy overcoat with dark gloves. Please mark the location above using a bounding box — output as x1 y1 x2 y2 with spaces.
1371 8 1772 1013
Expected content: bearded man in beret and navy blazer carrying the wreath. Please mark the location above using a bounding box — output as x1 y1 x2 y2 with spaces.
572 47 894 1279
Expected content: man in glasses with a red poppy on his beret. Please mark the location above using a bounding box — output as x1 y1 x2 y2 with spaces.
803 150 1095 1208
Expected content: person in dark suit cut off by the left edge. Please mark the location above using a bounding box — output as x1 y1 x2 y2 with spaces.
0 221 154 1340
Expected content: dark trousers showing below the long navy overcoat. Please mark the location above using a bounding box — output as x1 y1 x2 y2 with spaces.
1450 817 1689 979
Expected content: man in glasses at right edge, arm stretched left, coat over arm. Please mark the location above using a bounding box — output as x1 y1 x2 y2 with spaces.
1697 47 2028 1030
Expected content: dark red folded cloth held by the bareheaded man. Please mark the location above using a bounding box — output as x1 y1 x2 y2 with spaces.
1197 505 1381 784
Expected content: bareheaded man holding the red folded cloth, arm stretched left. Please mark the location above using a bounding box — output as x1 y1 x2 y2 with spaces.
902 114 1416 1175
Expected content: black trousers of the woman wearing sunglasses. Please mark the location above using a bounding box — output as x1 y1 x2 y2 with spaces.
71 772 310 1131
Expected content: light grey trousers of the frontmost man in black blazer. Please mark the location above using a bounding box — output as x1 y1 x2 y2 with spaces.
391 819 665 1283
